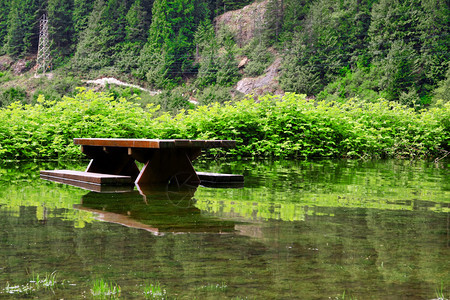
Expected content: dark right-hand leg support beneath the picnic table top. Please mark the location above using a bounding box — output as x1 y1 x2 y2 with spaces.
135 149 200 186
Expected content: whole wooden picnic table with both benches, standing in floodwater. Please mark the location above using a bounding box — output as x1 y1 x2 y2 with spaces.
41 138 243 186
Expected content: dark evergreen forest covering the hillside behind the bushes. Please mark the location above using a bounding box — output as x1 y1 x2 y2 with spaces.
0 0 450 107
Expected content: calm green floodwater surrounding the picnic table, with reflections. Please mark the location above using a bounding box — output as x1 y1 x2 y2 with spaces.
0 160 450 299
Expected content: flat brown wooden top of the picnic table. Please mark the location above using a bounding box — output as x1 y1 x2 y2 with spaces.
73 138 236 149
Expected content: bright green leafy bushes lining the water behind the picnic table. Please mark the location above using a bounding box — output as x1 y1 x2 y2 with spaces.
0 89 450 159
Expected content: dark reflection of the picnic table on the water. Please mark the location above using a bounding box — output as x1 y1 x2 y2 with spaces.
74 186 236 235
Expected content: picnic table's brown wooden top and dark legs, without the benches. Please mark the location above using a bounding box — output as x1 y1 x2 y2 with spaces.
74 138 236 185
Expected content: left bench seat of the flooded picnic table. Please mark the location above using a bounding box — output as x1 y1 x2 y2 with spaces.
41 170 133 185
